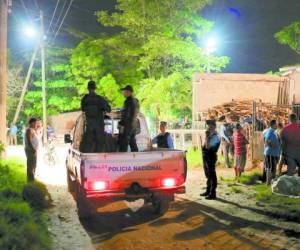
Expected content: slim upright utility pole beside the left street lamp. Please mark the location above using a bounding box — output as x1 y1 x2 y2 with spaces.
40 11 47 145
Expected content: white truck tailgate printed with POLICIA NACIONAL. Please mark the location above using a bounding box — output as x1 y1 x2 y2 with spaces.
81 151 186 190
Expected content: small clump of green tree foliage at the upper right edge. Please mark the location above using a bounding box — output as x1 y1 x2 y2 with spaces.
275 22 300 55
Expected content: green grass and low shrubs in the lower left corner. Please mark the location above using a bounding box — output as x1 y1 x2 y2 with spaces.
0 159 51 250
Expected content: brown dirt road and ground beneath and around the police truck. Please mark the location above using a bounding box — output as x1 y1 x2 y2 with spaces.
6 148 300 250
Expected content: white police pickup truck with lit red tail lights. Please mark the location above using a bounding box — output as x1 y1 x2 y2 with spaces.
65 112 187 218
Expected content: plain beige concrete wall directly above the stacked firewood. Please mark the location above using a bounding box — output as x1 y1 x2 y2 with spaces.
193 73 286 119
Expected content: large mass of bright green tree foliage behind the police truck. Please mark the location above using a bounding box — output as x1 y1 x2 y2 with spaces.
12 0 229 122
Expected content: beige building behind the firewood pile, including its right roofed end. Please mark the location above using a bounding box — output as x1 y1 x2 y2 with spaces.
192 70 300 124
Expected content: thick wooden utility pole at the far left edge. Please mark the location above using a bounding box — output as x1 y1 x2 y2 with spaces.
0 0 8 157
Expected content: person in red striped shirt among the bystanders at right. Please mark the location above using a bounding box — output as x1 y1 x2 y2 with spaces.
233 123 249 182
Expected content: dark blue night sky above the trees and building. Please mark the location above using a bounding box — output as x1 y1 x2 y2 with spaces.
9 0 300 73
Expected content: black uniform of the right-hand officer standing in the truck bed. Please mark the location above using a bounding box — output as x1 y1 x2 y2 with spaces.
119 96 140 152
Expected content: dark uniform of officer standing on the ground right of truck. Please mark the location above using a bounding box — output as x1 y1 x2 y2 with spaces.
202 133 220 197
